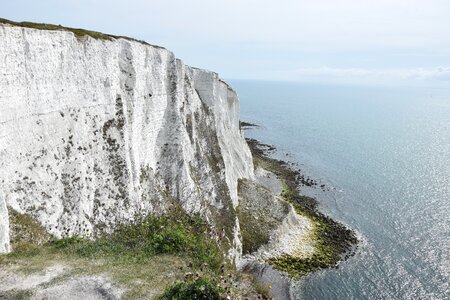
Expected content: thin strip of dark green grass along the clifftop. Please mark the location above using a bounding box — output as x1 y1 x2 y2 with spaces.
0 18 164 49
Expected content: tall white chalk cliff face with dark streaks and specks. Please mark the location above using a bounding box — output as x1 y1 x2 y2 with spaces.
0 24 254 257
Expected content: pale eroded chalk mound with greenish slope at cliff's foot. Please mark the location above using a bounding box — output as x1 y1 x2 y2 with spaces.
237 176 315 265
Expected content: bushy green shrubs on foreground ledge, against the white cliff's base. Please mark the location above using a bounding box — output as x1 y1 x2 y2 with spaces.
47 210 224 270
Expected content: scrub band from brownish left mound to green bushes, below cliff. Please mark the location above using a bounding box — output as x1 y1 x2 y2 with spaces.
7 208 224 271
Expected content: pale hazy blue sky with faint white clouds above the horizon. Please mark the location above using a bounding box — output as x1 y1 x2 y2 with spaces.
0 0 450 86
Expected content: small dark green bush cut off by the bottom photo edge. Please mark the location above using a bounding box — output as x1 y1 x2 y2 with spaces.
159 278 225 300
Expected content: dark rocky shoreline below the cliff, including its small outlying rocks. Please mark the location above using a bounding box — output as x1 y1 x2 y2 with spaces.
241 122 359 290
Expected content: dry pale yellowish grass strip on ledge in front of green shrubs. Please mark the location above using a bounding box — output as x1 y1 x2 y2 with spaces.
0 247 190 299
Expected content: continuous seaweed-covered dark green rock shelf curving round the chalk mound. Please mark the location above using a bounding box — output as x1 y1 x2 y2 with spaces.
244 140 358 278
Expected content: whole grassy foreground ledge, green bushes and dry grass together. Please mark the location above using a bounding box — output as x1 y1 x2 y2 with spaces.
0 209 235 299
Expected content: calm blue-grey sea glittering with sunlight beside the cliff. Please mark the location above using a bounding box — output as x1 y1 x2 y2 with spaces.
230 80 450 300
